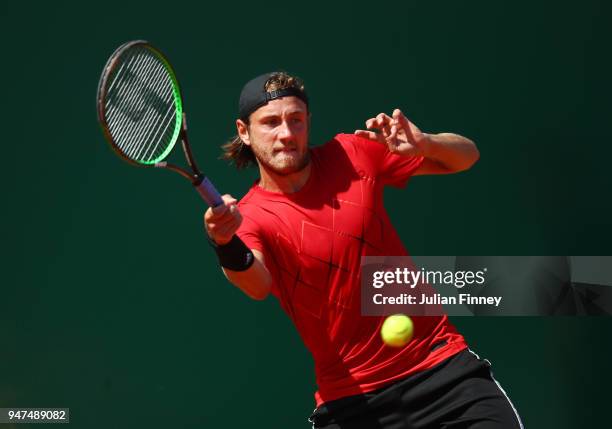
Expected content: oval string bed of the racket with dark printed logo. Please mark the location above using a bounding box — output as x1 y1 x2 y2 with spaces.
104 47 181 164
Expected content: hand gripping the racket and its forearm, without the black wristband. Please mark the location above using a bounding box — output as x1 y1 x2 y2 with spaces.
204 195 272 300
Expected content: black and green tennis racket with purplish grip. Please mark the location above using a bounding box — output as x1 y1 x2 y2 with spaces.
97 40 223 207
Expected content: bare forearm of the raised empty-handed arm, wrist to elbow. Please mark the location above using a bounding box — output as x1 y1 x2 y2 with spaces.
423 133 480 173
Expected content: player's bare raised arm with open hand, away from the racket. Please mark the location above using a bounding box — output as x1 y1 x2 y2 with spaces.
355 109 480 175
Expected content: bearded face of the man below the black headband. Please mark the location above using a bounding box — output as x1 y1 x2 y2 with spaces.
238 97 309 176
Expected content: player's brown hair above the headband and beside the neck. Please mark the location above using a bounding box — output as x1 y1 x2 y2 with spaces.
221 72 304 169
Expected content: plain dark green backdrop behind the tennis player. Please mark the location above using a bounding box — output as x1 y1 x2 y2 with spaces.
0 0 612 429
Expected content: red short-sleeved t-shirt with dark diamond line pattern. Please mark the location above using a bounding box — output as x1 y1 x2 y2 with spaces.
238 134 467 406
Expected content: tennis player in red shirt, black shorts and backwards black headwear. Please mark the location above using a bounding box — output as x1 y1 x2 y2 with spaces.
204 73 521 429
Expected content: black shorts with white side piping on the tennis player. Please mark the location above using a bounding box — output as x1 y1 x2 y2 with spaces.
309 350 523 429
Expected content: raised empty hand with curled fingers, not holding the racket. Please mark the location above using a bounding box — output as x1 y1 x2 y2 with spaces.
355 109 429 157
